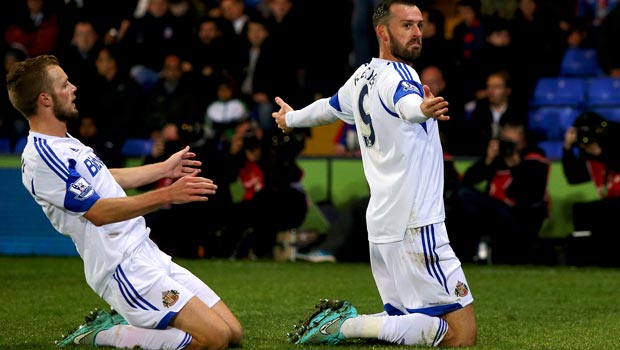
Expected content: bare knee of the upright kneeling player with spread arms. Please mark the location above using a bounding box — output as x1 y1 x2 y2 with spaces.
441 304 478 347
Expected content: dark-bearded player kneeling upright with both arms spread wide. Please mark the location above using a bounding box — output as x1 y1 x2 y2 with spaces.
273 0 477 347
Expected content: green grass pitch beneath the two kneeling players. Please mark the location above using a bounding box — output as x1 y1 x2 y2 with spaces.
0 256 620 350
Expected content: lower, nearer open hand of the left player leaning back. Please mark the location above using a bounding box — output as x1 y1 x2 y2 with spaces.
166 169 217 204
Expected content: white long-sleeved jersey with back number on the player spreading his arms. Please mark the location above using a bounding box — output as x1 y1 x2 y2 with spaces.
287 58 445 243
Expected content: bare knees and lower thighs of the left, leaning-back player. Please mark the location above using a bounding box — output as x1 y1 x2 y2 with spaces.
170 297 243 350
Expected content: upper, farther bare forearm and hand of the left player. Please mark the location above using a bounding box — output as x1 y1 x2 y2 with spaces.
110 146 202 190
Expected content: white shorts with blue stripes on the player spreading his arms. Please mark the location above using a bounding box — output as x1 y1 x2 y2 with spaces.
370 222 474 316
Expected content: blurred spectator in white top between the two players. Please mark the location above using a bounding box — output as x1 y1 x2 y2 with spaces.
204 77 250 138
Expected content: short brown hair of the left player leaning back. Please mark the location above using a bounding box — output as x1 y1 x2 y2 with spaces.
6 55 60 118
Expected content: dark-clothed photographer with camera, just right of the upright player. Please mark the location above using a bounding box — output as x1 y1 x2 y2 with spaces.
448 121 550 264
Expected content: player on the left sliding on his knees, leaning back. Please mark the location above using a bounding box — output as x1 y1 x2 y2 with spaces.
7 56 242 349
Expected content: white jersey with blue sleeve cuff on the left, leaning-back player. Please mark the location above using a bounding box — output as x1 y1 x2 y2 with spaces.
22 131 149 295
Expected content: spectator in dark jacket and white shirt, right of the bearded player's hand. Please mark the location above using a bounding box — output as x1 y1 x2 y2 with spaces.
467 70 528 155
